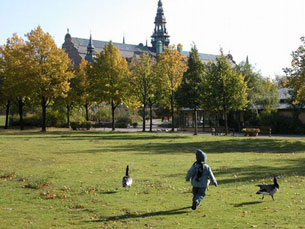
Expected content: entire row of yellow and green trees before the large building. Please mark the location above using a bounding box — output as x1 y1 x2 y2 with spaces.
0 27 278 131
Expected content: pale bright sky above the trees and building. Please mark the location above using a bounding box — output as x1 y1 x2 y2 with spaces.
0 0 305 78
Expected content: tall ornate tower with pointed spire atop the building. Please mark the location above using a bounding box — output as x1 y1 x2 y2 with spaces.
151 0 169 51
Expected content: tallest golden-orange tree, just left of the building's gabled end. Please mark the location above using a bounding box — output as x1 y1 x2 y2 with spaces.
27 26 72 132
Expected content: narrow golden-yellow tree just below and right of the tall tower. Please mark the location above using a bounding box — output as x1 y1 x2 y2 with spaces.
157 46 187 132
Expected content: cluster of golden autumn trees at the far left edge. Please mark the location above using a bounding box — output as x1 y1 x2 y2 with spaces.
0 27 73 131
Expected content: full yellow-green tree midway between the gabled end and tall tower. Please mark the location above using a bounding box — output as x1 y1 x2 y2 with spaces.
89 41 130 130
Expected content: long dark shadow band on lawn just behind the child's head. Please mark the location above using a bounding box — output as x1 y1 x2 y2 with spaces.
124 138 305 154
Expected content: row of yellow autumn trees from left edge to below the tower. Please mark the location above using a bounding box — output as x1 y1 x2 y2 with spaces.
0 27 187 131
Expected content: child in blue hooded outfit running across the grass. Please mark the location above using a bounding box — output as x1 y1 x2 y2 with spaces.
185 149 217 210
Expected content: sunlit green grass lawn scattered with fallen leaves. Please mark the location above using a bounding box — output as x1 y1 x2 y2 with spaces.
0 131 305 229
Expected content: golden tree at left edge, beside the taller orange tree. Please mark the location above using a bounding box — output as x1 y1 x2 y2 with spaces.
0 34 34 130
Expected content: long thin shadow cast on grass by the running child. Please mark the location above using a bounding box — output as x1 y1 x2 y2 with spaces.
88 207 191 222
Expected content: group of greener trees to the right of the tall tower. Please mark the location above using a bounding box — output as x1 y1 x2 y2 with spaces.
176 45 279 134
